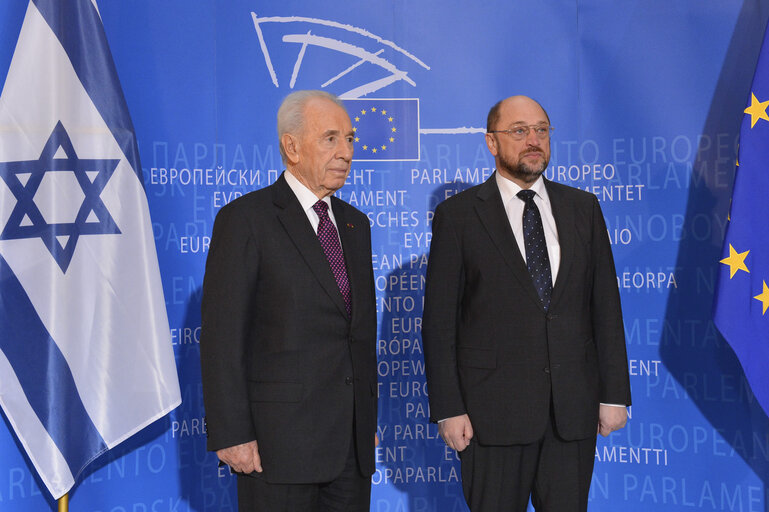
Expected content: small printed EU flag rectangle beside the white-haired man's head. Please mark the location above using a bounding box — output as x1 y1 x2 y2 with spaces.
344 98 419 162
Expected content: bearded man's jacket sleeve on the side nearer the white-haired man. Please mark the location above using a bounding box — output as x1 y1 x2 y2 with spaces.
422 205 467 422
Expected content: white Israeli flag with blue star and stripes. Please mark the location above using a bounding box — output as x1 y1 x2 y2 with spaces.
0 0 181 498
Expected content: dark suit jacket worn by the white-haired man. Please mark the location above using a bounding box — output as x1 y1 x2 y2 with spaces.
200 176 377 483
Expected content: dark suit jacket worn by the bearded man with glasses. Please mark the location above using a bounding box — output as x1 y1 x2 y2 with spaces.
423 175 630 445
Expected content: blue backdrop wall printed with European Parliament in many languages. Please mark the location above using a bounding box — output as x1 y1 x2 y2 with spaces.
0 0 769 512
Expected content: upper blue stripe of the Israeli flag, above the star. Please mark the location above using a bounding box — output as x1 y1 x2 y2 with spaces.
32 0 144 182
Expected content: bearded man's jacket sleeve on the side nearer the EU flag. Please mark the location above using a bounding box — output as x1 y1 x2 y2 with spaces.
591 197 630 405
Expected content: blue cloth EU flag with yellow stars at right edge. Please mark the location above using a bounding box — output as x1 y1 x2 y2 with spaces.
714 23 769 413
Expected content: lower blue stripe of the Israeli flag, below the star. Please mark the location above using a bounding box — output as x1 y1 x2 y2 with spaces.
0 256 107 476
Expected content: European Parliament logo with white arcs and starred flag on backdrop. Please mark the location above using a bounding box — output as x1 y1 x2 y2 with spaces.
251 12 430 162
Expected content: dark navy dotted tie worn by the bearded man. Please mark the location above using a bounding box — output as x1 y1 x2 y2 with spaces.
518 190 553 311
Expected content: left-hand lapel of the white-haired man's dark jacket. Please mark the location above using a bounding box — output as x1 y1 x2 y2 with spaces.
272 176 347 316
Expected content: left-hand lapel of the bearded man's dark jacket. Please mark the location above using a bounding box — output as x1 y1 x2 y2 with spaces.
475 174 542 306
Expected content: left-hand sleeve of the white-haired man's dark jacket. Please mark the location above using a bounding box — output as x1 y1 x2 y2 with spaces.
200 205 258 450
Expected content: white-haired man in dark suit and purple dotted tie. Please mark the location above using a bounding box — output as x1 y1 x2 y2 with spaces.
200 91 377 512
